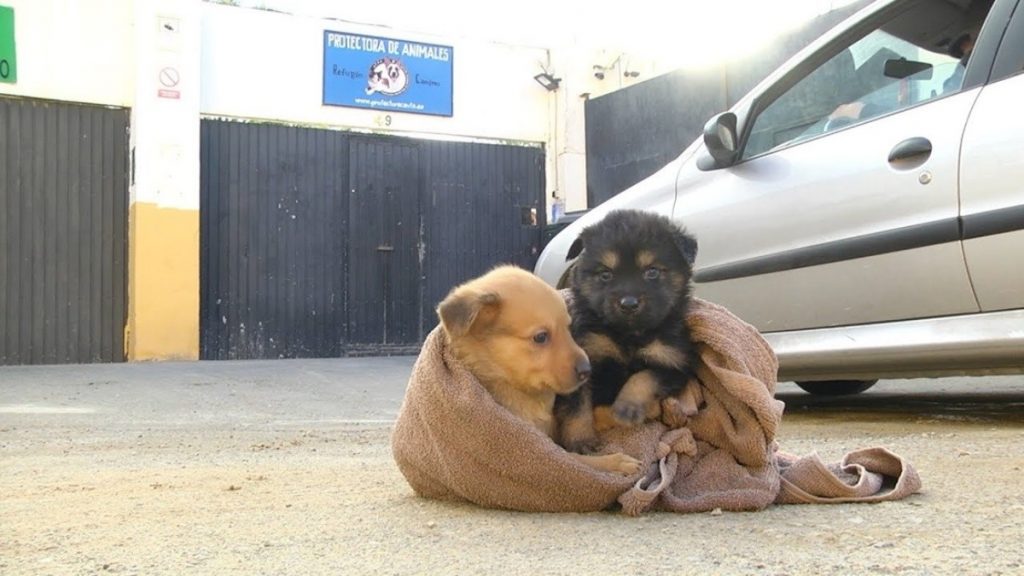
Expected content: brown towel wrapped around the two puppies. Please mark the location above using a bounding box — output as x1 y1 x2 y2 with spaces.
392 299 921 515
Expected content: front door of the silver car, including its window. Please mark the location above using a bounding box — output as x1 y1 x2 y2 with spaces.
674 0 988 331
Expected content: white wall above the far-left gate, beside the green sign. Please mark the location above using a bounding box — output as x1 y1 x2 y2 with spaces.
0 0 134 107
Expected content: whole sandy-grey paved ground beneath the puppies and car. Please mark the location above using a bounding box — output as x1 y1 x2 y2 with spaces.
0 358 1024 575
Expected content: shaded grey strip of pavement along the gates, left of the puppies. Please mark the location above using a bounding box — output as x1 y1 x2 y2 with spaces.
0 357 415 429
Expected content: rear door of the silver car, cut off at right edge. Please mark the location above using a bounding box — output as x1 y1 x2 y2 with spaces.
961 5 1024 312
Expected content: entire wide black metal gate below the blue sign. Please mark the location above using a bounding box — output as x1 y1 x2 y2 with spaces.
200 119 544 359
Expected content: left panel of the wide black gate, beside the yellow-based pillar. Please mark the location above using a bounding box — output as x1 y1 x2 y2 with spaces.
200 120 348 360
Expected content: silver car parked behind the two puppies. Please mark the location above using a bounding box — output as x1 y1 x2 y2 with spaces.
537 0 1024 394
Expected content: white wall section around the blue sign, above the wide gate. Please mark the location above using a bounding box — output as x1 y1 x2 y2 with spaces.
201 3 551 142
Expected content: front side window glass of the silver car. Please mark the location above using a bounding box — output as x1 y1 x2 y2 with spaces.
742 0 991 159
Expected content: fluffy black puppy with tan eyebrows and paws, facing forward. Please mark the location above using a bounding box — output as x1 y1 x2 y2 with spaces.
557 210 697 451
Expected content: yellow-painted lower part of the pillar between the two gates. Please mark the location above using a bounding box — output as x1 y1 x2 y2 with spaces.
125 202 200 361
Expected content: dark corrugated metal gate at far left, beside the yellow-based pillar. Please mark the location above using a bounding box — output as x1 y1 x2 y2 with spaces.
0 98 129 364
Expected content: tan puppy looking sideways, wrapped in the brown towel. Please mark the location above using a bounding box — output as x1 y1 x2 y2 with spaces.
437 266 640 476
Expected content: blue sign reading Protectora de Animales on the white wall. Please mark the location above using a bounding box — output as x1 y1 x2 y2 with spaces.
324 30 453 116
